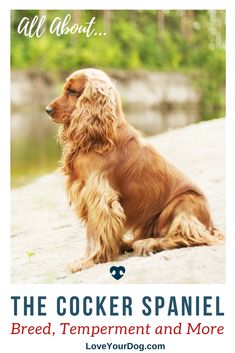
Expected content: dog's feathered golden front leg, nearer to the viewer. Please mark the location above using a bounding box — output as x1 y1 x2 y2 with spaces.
70 175 126 272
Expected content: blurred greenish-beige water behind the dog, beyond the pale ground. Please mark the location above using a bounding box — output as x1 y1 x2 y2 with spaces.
11 108 219 188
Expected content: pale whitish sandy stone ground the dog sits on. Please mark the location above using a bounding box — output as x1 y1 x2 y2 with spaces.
11 119 225 284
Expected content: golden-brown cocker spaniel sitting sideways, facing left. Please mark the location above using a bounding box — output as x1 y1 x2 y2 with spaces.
46 69 223 272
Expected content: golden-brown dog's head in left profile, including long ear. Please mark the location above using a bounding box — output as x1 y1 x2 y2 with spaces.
46 69 122 153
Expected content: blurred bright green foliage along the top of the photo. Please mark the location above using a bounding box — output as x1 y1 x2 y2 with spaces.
11 10 225 111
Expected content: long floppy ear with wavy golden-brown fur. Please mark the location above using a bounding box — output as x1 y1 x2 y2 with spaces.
68 78 118 153
